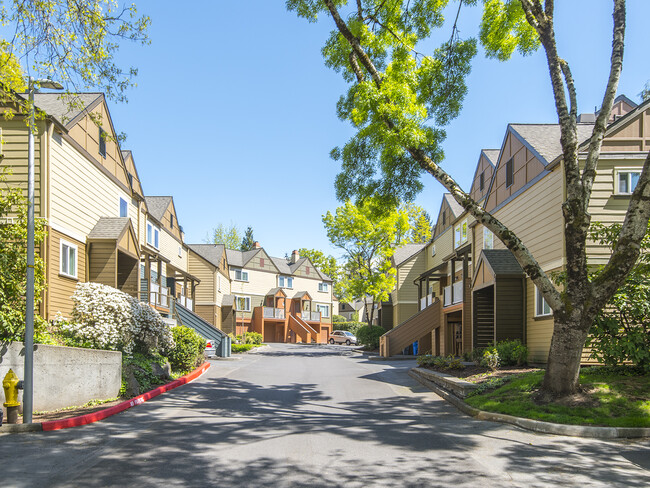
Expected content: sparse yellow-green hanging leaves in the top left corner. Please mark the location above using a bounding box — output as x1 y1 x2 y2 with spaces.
1 0 150 100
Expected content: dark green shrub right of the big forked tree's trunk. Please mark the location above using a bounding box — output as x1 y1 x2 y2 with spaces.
586 223 650 371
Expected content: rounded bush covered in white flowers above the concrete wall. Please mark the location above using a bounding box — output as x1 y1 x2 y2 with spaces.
62 283 174 354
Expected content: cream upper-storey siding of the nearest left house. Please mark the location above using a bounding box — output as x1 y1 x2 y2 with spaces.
49 135 138 236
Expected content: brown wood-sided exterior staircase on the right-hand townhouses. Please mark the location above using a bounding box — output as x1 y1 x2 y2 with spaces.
379 298 440 357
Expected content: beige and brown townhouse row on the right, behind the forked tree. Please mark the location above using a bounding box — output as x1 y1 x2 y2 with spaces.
381 96 650 363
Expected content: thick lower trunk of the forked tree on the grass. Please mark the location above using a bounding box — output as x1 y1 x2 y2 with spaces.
543 316 589 400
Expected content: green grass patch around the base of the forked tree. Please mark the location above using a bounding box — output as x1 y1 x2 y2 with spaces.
465 367 650 427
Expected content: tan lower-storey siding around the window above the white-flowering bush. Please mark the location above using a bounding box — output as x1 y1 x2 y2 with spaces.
45 227 86 320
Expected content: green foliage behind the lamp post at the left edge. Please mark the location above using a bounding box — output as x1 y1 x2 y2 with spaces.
0 168 47 341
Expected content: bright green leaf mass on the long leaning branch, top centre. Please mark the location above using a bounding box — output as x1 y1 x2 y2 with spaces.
287 0 476 206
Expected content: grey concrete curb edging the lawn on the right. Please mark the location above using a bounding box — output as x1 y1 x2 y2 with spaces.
408 368 650 439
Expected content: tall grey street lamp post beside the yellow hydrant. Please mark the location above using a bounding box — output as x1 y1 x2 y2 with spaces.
23 76 63 424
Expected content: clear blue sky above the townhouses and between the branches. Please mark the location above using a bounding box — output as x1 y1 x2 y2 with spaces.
101 0 650 257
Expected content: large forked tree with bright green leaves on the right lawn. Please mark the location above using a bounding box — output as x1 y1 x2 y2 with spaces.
287 0 650 399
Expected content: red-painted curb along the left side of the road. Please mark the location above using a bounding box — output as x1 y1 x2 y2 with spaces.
0 362 210 434
